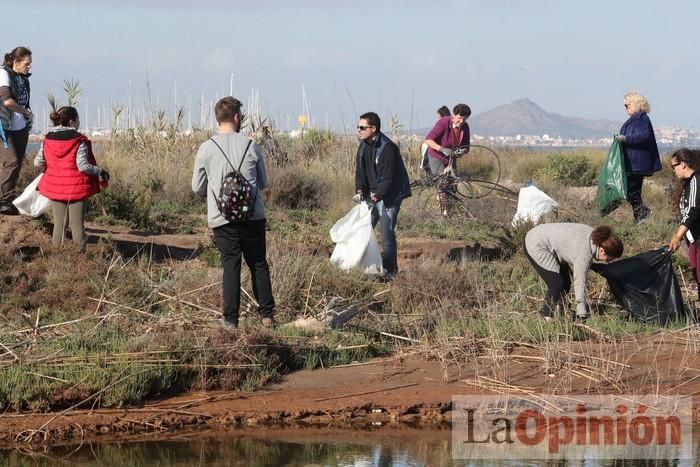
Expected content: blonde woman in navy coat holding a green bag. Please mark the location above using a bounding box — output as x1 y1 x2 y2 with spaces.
615 92 661 224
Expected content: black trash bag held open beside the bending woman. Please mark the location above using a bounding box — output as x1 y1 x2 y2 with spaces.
592 247 685 325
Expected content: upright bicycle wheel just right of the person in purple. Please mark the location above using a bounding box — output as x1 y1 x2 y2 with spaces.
457 144 501 198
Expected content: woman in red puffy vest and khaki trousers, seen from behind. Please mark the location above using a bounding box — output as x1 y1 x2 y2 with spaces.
34 106 109 249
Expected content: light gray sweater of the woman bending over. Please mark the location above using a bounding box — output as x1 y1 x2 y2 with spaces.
525 223 598 316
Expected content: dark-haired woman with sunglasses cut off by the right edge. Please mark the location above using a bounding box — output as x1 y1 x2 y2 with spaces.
668 148 700 299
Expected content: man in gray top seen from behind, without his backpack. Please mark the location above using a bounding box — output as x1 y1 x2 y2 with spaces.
192 96 275 330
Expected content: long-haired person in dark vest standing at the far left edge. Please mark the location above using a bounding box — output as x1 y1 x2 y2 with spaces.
0 47 33 215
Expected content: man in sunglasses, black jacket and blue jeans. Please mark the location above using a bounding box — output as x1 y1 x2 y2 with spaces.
353 112 411 280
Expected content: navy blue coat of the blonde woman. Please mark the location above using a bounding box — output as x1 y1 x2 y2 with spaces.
620 112 661 175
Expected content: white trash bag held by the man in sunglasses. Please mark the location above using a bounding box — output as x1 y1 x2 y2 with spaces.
330 202 384 274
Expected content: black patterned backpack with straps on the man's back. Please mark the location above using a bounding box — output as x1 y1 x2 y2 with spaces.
209 138 257 222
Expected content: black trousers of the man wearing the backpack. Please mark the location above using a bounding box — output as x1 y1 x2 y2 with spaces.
214 219 275 324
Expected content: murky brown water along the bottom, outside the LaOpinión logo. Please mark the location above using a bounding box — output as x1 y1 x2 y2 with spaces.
0 428 693 467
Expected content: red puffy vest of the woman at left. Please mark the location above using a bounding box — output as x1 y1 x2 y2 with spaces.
38 131 100 201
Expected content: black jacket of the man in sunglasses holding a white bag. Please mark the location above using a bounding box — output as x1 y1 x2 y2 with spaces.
355 132 411 207
